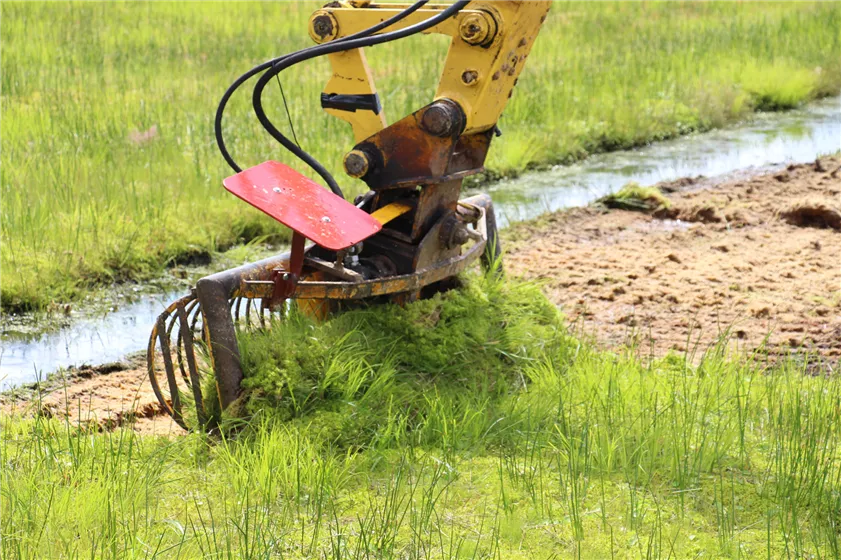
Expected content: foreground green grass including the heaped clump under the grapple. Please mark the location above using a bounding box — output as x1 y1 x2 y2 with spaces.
0 278 841 559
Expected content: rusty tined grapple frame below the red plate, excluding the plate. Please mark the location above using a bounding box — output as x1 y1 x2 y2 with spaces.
146 194 500 430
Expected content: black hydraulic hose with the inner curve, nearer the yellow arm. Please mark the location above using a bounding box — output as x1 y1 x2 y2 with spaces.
251 0 472 196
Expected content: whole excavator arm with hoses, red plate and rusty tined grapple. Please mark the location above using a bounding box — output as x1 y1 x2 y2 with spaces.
147 0 551 430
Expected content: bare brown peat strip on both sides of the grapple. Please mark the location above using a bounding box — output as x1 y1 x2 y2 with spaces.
0 157 841 434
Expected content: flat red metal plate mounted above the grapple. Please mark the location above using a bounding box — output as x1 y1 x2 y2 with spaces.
223 161 382 251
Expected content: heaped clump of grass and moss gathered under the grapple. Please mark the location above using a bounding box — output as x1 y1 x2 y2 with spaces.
240 277 564 447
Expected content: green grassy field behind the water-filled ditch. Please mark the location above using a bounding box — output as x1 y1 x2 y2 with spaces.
0 1 841 311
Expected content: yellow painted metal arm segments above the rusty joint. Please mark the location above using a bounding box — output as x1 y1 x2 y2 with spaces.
309 0 552 142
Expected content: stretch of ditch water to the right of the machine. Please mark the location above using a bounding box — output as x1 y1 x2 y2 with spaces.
488 97 841 225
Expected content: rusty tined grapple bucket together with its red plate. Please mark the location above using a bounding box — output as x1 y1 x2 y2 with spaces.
147 161 499 429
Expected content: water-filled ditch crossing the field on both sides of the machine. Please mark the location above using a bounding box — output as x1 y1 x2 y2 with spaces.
0 97 841 390
